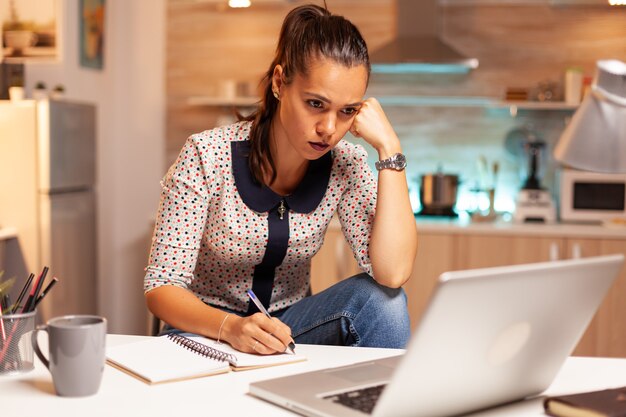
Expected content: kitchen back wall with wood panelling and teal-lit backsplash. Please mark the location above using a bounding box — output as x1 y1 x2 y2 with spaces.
166 0 626 214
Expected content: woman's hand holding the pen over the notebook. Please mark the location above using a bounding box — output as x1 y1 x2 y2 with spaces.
222 313 293 355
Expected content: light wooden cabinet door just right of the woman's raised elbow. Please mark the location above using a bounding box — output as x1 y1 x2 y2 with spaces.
404 233 455 328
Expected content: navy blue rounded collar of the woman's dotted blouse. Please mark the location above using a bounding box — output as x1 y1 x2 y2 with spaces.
230 140 333 213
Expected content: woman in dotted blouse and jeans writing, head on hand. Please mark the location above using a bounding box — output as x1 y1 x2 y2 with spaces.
144 5 417 354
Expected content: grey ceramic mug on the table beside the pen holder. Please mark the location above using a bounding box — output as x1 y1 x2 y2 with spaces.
32 315 107 397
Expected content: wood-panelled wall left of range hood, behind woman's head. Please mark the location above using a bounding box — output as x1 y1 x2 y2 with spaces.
166 0 395 163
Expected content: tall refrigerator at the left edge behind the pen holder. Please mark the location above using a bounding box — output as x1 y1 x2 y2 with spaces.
0 100 98 321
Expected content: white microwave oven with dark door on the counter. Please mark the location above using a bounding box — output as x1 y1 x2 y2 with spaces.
559 168 626 222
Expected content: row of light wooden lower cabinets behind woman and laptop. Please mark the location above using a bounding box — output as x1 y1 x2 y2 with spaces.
312 225 626 357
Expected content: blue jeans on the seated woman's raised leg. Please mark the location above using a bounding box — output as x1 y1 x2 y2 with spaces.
162 273 411 349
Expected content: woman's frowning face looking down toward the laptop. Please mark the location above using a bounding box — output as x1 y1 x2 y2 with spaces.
272 58 367 160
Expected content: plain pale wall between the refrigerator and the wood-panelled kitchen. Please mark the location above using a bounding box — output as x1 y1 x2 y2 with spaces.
17 0 166 334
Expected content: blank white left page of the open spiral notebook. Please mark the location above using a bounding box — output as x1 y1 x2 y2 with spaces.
107 336 230 383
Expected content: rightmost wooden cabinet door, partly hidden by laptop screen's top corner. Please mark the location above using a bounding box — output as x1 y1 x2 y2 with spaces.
566 239 626 357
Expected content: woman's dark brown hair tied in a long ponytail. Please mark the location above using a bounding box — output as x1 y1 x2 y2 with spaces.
243 4 371 185
